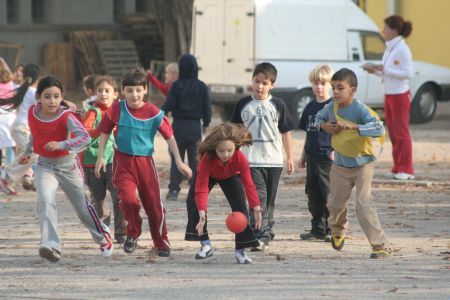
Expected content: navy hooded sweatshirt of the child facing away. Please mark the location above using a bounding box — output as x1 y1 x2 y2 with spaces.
161 54 211 140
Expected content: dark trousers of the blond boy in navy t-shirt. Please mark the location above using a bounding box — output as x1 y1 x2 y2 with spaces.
305 157 333 235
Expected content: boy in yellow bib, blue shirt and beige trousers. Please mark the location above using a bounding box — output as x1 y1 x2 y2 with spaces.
316 68 392 258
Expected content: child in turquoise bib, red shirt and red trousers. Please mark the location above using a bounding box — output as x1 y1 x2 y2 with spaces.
95 69 192 257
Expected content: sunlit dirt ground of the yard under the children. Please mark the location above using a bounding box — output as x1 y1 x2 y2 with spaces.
0 102 450 299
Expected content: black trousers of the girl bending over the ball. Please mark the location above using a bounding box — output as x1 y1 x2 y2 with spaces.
184 175 259 249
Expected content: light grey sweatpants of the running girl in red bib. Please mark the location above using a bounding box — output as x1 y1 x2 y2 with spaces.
35 154 109 252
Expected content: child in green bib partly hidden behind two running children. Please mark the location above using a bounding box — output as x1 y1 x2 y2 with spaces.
80 76 126 244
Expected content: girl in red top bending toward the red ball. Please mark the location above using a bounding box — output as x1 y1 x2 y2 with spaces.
185 123 261 264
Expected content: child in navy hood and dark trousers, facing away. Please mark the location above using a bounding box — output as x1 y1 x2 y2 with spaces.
161 54 211 201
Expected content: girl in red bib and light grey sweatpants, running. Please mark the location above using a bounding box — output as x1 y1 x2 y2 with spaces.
20 75 113 262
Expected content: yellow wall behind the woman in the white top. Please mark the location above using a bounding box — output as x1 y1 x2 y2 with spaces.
365 0 450 68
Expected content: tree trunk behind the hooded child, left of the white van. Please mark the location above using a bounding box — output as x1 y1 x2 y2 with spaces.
148 0 193 61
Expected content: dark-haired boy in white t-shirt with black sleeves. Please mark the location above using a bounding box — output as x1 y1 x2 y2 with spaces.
231 62 294 251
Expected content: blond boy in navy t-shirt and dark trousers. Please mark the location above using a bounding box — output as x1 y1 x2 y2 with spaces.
298 65 333 242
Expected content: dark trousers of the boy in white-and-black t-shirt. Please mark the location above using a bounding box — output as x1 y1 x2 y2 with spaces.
250 167 283 242
